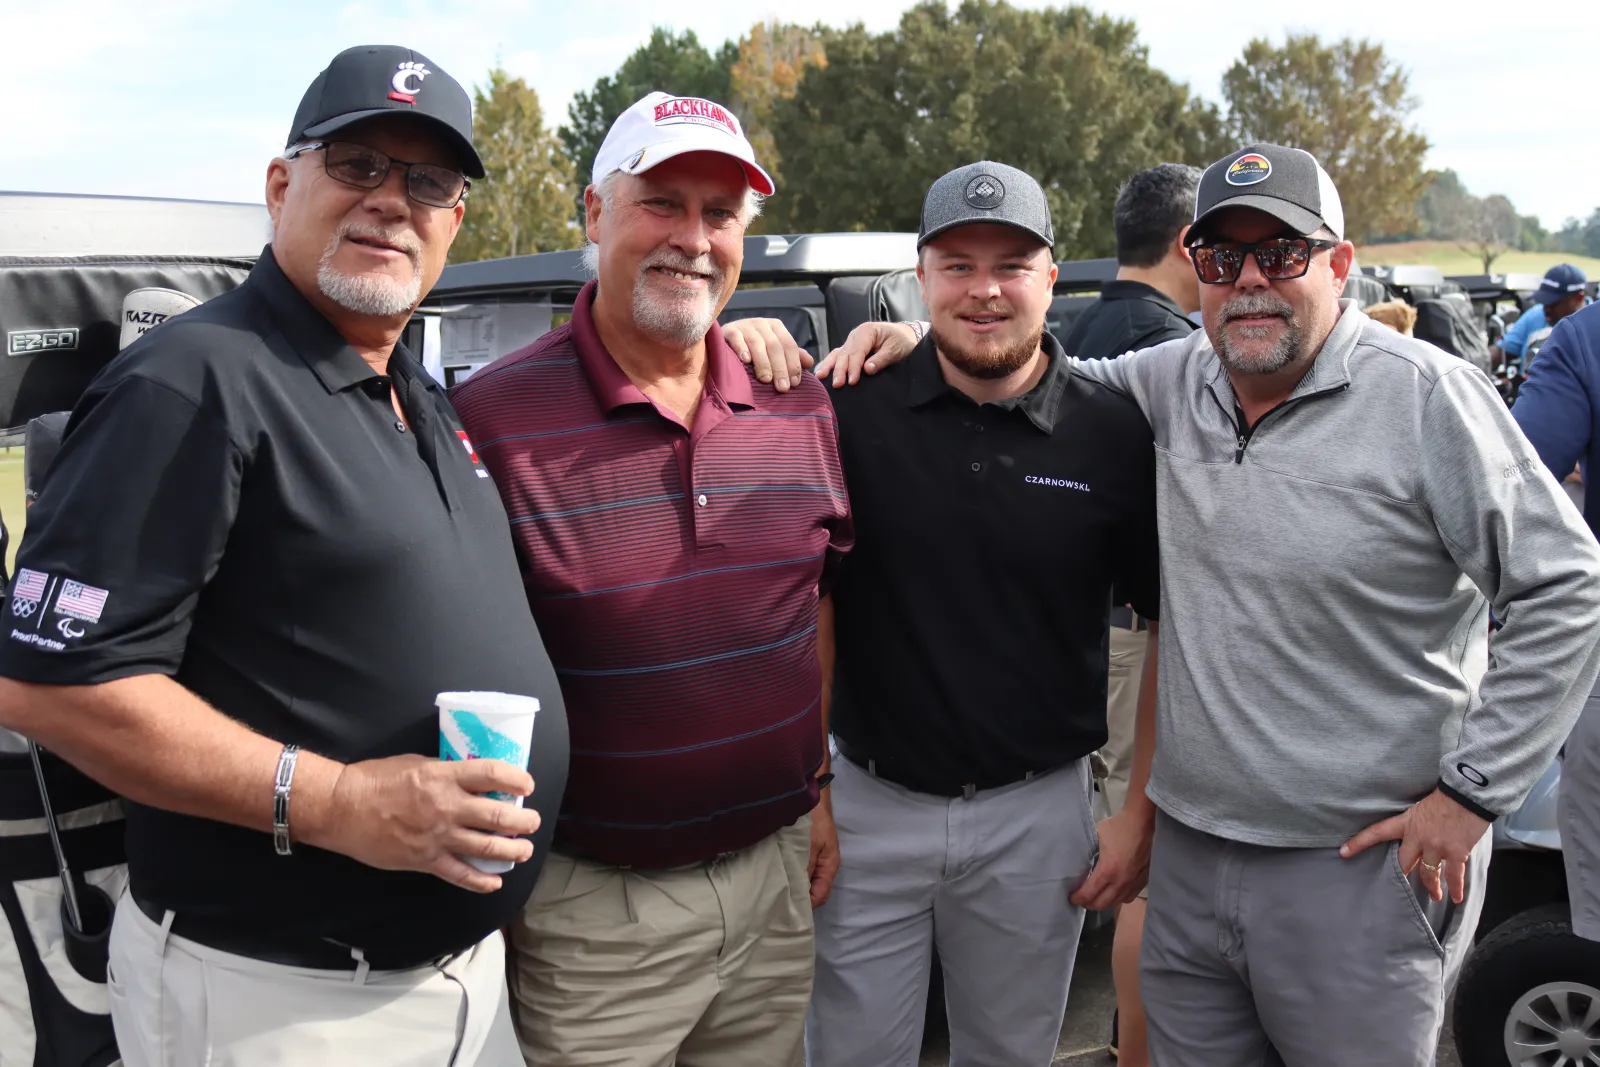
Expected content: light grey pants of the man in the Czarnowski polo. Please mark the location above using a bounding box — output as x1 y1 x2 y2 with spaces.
806 755 1098 1067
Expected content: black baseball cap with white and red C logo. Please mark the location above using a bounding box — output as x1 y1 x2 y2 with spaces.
285 45 483 178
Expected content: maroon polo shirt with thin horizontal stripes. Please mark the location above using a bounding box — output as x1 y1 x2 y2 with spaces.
451 283 851 867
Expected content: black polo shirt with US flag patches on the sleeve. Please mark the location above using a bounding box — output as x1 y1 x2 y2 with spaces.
0 250 566 966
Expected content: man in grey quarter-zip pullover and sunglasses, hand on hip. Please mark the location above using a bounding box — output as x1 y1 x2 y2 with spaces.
824 144 1600 1067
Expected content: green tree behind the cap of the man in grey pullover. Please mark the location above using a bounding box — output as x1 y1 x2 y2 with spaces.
1222 34 1429 243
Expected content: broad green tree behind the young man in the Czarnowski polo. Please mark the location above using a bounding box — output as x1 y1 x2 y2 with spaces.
766 0 1221 256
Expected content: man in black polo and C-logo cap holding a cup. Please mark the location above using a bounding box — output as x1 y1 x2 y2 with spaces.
0 46 566 1067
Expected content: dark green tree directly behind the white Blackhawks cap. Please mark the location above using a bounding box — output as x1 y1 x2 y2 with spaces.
560 26 739 207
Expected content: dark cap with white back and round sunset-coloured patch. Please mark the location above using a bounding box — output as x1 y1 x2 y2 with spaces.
1184 144 1344 245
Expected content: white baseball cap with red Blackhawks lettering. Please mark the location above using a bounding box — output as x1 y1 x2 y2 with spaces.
592 93 773 197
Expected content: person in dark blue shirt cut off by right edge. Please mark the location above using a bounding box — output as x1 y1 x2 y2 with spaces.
1512 300 1600 941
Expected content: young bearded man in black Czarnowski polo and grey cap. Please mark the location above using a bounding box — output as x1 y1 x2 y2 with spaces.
806 162 1160 1067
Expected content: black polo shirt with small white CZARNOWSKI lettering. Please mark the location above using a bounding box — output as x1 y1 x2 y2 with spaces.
830 333 1160 793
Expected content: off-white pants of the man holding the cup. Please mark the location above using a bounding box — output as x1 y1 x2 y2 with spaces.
107 894 522 1067
